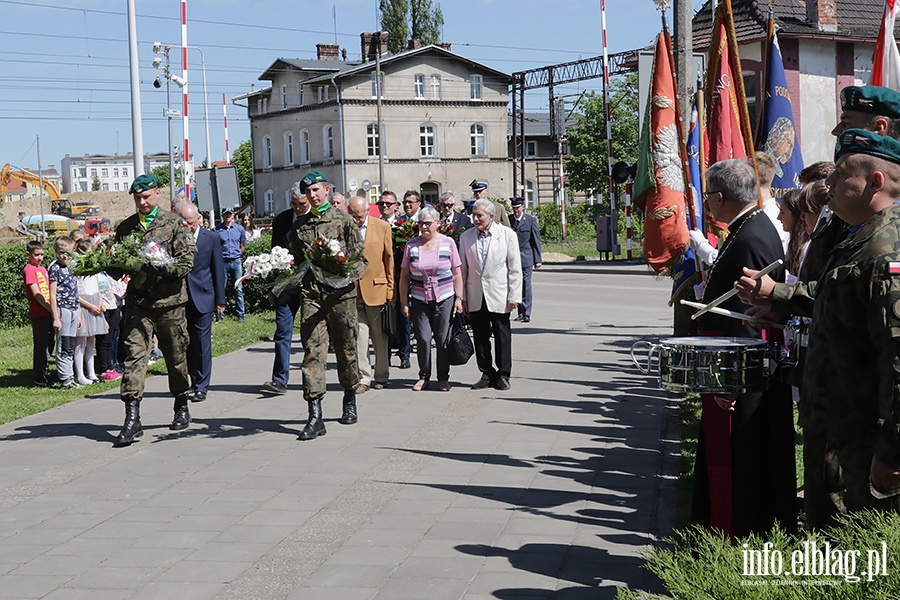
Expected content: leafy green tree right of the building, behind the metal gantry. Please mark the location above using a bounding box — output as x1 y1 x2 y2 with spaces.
565 74 639 207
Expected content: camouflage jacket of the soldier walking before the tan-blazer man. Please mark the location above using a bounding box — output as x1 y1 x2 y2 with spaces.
288 207 365 300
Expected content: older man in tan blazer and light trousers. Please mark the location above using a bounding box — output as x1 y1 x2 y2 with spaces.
347 196 394 394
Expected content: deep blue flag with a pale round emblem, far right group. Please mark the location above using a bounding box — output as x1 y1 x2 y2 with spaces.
758 33 803 199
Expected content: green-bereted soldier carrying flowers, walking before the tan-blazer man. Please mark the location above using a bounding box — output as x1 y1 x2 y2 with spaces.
288 171 363 440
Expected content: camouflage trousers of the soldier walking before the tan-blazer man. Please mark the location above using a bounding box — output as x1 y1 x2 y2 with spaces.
300 297 359 400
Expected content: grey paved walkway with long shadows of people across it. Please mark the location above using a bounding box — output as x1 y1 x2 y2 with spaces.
0 263 678 600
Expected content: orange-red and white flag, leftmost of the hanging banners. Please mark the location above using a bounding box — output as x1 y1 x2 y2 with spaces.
635 33 690 273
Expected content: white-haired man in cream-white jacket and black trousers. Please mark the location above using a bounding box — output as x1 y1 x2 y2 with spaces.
459 199 522 390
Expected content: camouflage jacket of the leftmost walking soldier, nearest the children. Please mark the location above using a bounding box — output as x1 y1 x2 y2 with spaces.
116 208 196 308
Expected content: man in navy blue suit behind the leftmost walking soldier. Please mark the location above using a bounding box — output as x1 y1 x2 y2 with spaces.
179 204 225 402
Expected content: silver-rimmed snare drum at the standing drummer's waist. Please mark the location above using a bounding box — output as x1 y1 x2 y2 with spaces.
631 337 770 395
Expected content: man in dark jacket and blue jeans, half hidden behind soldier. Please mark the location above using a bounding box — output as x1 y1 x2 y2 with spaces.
263 181 309 395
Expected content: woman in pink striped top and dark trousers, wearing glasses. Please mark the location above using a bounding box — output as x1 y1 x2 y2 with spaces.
400 207 462 392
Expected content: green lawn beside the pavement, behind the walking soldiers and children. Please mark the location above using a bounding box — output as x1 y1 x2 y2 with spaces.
0 311 275 424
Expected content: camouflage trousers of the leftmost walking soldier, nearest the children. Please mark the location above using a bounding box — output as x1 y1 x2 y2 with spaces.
121 304 191 403
